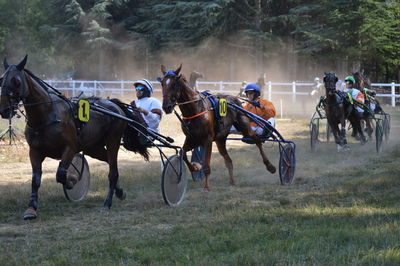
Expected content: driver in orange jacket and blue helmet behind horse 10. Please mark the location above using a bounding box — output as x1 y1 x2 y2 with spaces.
244 83 276 135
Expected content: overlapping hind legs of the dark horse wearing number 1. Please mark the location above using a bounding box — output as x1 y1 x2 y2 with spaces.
104 142 124 210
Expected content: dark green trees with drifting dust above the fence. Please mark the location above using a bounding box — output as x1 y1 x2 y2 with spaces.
0 0 400 82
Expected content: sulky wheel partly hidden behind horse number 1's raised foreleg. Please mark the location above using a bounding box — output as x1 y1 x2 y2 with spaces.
63 153 90 202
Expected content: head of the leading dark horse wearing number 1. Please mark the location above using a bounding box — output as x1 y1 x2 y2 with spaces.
0 55 29 118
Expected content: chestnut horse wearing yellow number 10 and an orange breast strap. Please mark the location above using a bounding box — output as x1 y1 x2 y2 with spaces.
161 65 276 191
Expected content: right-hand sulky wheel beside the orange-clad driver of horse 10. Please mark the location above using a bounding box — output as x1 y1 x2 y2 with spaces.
279 143 296 185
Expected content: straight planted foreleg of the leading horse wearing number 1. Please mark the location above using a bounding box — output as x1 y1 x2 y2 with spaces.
23 149 44 220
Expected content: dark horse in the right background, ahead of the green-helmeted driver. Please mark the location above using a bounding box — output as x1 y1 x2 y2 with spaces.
323 73 366 151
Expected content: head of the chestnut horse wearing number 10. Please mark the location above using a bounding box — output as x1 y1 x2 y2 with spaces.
159 64 182 114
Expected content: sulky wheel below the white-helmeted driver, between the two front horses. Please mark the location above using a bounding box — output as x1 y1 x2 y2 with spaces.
161 155 187 206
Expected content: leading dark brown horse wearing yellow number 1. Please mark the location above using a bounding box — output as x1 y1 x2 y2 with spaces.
0 56 147 220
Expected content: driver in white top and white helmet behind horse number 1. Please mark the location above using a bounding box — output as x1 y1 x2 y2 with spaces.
131 79 162 132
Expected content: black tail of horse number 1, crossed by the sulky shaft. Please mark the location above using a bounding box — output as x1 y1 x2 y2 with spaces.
110 98 150 161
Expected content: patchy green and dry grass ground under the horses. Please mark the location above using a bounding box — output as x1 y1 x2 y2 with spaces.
0 105 400 265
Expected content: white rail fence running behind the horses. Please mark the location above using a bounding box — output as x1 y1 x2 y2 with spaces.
46 80 400 109
